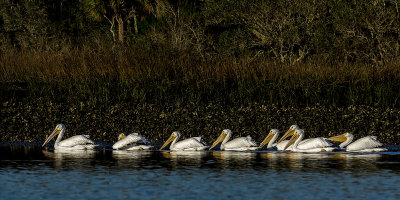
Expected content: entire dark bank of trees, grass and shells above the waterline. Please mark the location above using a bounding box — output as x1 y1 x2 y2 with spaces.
0 0 400 144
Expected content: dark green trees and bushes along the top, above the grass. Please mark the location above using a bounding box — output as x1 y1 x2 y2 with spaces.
0 0 400 62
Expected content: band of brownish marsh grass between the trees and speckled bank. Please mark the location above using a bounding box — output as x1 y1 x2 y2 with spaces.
0 45 400 106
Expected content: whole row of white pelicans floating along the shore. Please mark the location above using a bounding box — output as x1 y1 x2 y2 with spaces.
42 124 388 152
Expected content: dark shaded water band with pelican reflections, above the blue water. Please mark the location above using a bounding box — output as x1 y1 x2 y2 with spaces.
0 146 400 172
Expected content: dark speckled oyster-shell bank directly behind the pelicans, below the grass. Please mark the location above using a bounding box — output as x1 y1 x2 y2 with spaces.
0 100 400 144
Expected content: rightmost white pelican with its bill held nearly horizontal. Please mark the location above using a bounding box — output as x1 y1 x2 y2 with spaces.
328 133 388 152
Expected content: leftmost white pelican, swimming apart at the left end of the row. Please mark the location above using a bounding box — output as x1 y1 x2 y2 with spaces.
42 124 98 150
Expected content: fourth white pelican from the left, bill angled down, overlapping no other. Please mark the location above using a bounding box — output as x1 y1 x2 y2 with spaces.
209 129 258 151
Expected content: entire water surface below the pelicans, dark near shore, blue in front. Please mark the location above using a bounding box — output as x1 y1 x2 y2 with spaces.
0 145 400 199
